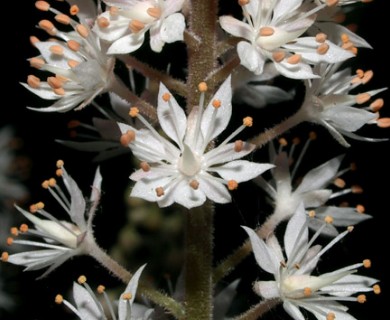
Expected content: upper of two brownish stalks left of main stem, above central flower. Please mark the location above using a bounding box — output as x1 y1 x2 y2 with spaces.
118 55 187 96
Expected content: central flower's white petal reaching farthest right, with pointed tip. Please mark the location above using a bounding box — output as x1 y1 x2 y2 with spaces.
212 160 274 182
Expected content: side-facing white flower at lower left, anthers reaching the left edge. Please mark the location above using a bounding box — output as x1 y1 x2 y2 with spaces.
2 160 102 277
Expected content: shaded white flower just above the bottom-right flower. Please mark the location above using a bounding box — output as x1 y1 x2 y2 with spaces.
253 133 372 236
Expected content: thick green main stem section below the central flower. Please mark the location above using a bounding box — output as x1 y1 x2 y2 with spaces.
185 203 213 320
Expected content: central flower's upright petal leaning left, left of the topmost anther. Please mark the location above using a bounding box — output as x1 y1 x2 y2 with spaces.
157 83 187 147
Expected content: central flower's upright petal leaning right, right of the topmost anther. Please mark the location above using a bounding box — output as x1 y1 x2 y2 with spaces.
201 76 232 143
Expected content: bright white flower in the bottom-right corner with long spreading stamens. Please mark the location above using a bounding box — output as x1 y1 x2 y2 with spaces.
243 205 380 320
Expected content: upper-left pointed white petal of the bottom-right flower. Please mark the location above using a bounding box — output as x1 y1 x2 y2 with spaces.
242 226 280 274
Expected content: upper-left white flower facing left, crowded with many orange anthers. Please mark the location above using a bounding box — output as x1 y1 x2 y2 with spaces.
22 1 115 112
